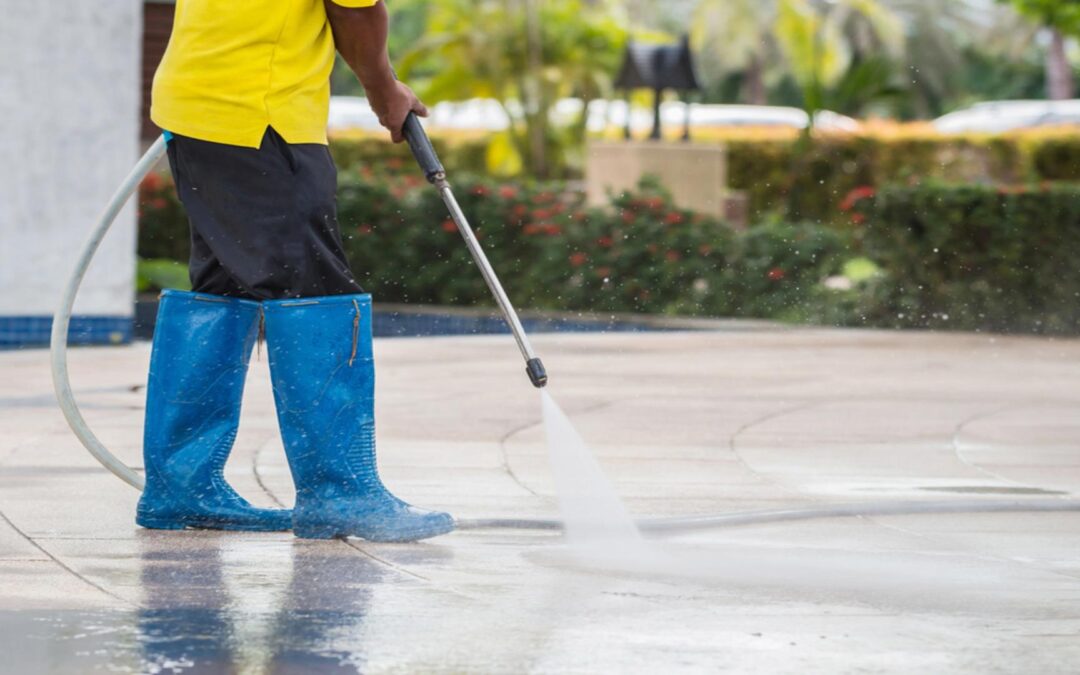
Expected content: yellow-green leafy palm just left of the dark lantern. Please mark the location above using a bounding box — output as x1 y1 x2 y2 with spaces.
401 0 626 178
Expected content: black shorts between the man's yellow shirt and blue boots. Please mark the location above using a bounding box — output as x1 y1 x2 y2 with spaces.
168 129 363 300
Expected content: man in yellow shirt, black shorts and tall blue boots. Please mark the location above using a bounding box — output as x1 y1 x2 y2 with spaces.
136 0 454 541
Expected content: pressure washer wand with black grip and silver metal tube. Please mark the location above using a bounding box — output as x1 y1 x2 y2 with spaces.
402 112 548 389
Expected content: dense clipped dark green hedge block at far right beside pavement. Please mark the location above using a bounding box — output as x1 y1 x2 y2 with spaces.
853 184 1080 335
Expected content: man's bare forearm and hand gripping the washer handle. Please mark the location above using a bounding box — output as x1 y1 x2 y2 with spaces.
323 0 428 143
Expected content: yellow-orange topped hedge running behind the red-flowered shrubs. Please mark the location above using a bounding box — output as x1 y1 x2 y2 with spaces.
330 132 1080 224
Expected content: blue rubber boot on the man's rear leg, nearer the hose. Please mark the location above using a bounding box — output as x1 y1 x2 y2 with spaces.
135 291 292 531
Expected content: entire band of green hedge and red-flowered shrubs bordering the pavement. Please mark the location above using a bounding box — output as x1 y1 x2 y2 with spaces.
132 167 1080 335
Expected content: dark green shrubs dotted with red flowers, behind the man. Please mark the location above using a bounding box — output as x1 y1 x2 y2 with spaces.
139 166 841 316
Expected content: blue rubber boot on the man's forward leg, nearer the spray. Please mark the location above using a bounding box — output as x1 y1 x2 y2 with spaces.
262 295 454 541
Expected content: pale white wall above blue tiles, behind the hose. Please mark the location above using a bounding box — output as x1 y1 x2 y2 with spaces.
0 0 143 319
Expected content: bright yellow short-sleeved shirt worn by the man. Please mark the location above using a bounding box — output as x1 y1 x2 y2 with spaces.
150 0 378 148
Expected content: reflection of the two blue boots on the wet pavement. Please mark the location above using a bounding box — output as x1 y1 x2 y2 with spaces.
136 534 386 675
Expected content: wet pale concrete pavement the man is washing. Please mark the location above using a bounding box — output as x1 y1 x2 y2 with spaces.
0 329 1080 673
